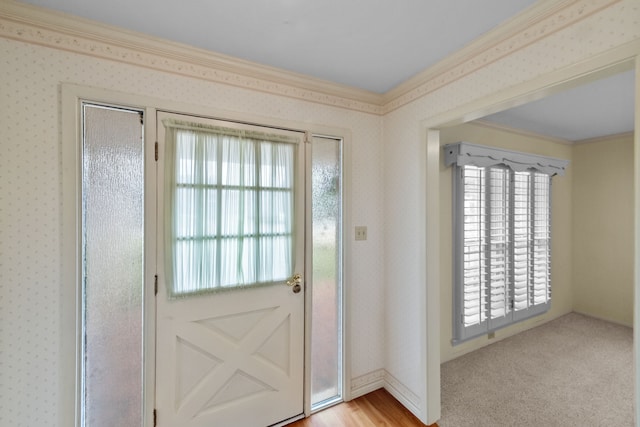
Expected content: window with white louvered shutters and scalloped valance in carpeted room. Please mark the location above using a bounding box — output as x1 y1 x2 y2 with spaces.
445 142 568 344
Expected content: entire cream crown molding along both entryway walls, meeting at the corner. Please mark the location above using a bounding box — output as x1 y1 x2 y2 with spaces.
0 0 621 115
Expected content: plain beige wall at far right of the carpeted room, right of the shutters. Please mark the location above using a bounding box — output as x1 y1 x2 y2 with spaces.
572 135 635 326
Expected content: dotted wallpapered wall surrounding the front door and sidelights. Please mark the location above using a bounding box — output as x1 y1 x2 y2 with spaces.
0 38 384 426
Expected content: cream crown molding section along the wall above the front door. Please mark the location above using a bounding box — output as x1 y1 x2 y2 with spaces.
0 0 382 115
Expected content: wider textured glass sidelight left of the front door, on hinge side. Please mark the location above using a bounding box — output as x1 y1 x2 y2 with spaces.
82 105 144 427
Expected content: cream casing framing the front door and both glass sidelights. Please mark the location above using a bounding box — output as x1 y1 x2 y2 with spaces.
58 83 351 427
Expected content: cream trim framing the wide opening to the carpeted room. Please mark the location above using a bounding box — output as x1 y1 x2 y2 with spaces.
422 57 640 422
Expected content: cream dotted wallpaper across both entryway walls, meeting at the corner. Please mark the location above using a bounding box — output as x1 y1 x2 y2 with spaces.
0 0 640 427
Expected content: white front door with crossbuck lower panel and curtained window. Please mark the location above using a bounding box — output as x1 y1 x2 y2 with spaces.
156 113 305 427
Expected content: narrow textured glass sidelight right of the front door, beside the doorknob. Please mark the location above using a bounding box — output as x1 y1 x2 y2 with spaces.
311 137 342 409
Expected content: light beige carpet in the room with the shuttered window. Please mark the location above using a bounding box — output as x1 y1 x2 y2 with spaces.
438 313 634 427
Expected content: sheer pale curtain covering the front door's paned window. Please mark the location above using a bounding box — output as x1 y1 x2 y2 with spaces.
163 120 297 297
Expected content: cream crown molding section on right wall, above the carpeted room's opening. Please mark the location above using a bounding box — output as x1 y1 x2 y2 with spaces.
384 0 621 114
